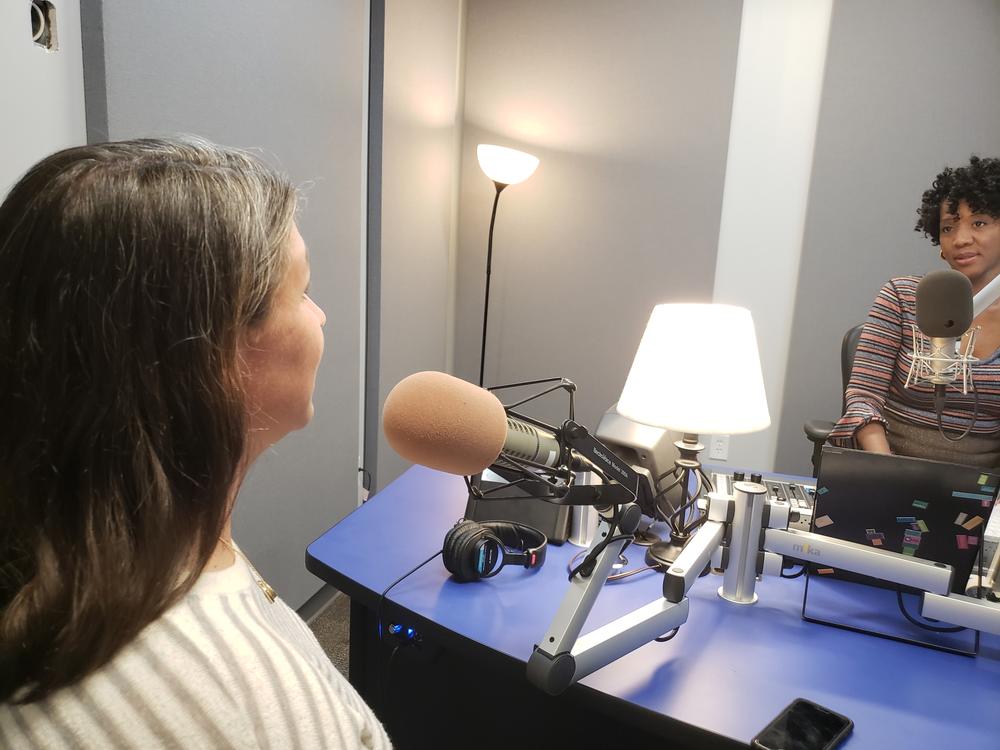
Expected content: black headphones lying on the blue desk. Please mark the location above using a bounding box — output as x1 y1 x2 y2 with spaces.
442 519 549 582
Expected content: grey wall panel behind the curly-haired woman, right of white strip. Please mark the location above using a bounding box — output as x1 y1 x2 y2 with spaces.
775 0 1000 473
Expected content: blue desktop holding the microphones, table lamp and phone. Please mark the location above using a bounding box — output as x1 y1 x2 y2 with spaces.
306 467 1000 750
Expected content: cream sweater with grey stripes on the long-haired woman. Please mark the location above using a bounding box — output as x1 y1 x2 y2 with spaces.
0 558 390 750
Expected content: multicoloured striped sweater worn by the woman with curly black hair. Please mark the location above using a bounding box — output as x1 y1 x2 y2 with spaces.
830 276 1000 448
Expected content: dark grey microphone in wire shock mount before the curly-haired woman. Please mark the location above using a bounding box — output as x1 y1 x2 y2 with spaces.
910 269 973 389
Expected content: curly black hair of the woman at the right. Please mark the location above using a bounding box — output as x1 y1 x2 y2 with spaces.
914 156 1000 245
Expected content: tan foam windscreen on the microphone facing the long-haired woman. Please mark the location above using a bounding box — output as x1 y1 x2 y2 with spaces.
382 372 507 475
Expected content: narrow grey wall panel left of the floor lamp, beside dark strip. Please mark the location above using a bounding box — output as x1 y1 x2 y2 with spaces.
376 0 464 487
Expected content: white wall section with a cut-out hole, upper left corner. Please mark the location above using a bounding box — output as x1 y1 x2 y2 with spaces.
0 0 87 196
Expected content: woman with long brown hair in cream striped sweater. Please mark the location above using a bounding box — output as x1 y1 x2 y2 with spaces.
0 139 389 748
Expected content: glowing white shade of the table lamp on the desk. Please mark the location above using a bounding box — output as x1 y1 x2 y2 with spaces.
618 304 771 435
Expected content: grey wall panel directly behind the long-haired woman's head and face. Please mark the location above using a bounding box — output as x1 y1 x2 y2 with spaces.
91 0 367 607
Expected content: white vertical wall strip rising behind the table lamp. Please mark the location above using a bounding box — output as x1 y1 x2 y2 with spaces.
712 0 833 471
